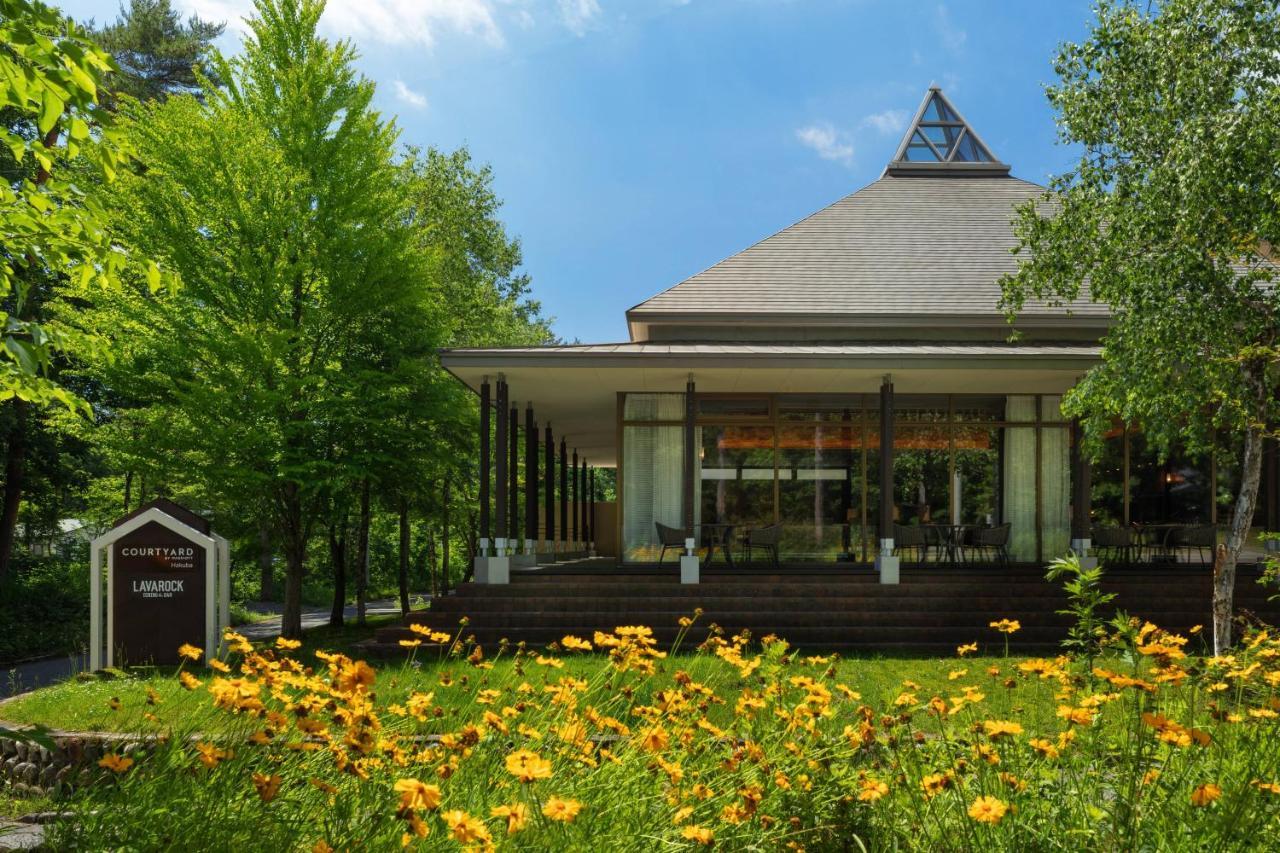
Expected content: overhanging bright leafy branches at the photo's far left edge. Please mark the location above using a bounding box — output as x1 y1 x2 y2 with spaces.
0 0 161 578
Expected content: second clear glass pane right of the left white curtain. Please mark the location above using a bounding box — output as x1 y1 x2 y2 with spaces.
778 410 863 562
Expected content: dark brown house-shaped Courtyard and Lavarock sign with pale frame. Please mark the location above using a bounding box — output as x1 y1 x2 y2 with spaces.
90 500 230 670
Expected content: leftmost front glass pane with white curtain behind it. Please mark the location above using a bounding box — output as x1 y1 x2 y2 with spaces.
622 422 685 562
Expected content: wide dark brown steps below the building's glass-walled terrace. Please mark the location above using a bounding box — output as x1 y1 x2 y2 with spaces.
378 560 1280 653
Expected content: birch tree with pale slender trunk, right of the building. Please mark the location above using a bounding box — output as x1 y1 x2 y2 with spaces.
1004 0 1280 652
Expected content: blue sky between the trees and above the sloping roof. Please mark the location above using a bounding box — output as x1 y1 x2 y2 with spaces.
61 0 1092 342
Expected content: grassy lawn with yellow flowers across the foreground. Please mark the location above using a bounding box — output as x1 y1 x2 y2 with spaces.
4 607 1280 850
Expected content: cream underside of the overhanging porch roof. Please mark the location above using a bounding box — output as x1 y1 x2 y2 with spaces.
447 357 1084 467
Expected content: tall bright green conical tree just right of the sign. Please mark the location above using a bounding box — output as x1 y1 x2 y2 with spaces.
96 0 436 635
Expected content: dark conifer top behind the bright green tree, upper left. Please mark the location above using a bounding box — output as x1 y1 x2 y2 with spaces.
91 0 225 101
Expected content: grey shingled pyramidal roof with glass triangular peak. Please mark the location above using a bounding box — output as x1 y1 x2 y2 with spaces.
627 88 1106 329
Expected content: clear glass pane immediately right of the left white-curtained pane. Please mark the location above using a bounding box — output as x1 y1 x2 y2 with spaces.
698 425 773 526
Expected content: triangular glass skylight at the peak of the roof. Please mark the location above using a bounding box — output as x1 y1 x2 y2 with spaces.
887 86 1009 175
